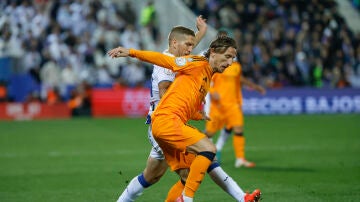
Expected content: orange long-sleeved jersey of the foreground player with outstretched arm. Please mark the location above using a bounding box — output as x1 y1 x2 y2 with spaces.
130 49 212 123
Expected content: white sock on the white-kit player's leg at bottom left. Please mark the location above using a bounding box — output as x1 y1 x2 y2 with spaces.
117 176 144 202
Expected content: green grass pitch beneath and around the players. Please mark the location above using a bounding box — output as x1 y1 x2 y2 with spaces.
0 115 360 202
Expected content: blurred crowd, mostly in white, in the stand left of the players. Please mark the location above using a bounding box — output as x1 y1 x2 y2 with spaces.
0 0 160 110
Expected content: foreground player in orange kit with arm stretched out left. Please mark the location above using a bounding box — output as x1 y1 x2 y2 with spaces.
108 37 260 201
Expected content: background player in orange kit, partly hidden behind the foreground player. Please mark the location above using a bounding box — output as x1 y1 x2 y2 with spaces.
205 31 266 168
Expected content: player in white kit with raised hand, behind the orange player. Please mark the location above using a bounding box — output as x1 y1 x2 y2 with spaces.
117 16 255 202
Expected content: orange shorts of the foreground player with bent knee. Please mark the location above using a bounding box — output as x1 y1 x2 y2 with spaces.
151 115 206 171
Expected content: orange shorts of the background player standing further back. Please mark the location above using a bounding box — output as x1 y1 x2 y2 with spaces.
205 104 244 133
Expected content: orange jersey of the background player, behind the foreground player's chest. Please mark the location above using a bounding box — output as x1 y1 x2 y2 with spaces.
210 62 242 104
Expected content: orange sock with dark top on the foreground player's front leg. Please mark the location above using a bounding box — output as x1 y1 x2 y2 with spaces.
184 152 215 198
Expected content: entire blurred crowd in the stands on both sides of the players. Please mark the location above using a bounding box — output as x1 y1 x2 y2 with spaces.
0 0 360 107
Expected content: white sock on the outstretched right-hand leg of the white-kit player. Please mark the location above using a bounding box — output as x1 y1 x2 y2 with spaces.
209 166 245 201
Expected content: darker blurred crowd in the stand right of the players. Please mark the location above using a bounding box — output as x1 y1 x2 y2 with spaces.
184 0 360 88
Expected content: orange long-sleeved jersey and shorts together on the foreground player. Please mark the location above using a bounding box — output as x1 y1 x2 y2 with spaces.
130 49 212 170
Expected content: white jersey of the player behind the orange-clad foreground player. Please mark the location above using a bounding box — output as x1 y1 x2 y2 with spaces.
146 50 176 124
